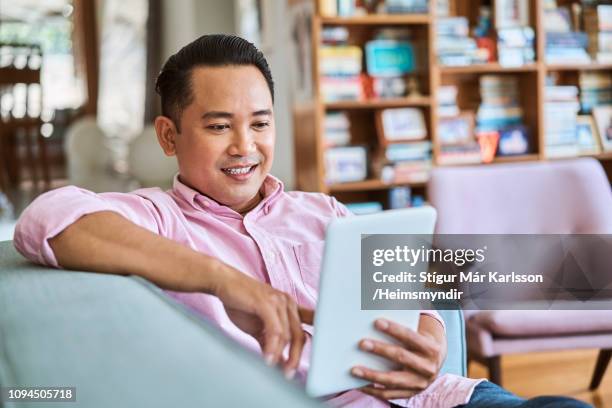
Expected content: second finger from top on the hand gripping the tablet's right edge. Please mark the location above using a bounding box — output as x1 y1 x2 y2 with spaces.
359 339 438 379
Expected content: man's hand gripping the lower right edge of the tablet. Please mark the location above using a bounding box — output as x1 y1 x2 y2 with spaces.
351 315 446 400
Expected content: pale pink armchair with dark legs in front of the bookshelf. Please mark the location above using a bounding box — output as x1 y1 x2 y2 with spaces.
428 159 612 390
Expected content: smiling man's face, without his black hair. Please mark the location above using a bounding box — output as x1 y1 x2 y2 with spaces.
158 65 275 212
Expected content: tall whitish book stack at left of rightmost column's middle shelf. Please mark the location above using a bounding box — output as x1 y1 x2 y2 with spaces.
544 85 580 158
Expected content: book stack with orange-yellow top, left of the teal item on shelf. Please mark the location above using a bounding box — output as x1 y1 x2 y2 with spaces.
319 45 364 102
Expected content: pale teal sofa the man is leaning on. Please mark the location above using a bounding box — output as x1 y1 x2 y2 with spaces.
0 241 466 408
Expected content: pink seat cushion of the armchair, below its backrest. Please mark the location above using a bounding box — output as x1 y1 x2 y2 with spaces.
468 310 612 337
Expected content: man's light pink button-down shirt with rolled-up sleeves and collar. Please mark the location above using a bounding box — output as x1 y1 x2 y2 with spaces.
14 176 479 408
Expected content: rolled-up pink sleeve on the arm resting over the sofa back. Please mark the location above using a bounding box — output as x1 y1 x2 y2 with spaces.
13 186 161 268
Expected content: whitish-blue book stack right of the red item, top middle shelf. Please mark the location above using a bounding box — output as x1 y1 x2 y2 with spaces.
497 27 535 67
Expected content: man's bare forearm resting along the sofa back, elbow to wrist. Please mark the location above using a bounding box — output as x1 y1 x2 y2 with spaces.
49 211 230 293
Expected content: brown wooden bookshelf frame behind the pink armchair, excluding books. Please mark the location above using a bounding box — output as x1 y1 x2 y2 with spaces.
294 0 612 203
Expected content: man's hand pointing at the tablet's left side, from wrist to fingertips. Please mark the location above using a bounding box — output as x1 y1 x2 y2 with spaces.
213 265 313 379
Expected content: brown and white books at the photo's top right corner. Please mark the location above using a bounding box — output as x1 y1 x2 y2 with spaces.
584 4 612 63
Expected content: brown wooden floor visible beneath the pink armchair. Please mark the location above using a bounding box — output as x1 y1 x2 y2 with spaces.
469 350 612 408
